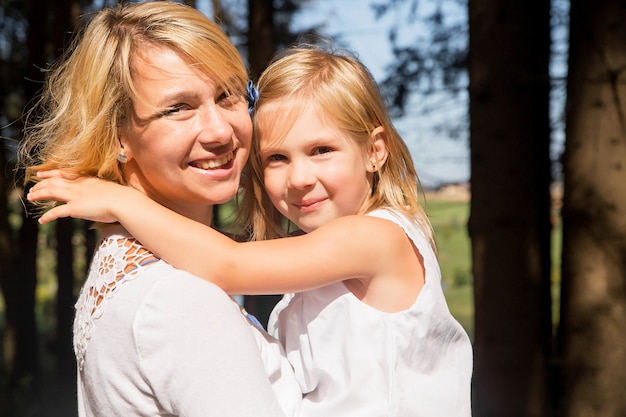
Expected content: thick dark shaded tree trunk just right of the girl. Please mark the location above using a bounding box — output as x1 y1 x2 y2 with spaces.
469 0 552 417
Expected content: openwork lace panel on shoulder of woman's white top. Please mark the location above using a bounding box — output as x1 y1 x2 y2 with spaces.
74 236 159 371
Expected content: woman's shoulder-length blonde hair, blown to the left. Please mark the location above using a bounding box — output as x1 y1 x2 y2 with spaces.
20 1 248 198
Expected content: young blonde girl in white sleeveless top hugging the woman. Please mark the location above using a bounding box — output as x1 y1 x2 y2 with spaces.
29 47 472 417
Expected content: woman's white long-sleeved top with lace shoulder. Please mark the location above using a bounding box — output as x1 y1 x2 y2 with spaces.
74 226 301 417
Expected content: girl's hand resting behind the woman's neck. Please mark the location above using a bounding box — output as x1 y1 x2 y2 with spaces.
26 170 124 224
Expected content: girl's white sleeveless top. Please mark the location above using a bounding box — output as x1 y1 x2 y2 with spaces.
268 210 473 417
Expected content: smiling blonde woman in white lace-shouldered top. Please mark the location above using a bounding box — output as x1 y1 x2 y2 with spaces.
21 2 301 417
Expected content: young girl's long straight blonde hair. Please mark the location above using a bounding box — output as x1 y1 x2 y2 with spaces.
242 45 435 247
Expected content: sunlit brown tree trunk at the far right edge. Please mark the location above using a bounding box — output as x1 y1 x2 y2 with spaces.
559 0 626 417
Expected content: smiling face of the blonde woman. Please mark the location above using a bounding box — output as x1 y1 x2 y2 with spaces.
121 47 252 224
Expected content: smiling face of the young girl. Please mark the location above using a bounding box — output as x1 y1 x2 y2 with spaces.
259 106 372 232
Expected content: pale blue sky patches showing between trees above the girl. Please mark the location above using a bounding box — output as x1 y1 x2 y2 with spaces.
197 0 469 186
